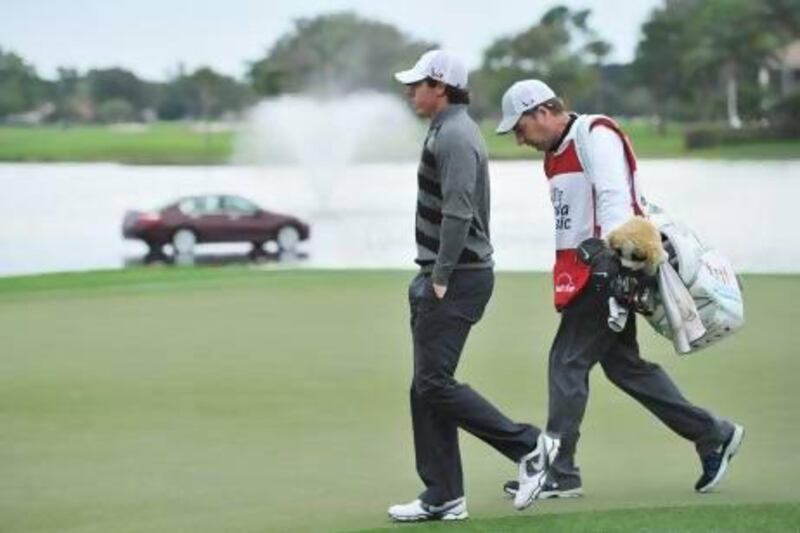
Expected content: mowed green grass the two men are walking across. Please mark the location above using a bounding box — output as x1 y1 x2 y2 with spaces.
0 268 800 532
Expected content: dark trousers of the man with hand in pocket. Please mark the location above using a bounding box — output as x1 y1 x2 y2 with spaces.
409 269 539 505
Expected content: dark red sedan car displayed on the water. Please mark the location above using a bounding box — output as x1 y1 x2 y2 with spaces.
122 195 310 255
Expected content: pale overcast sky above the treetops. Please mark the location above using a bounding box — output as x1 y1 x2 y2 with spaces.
0 0 663 81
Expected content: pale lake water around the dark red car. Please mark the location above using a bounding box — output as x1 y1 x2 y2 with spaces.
0 160 800 276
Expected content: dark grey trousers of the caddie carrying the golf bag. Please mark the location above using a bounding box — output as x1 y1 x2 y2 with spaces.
547 286 733 489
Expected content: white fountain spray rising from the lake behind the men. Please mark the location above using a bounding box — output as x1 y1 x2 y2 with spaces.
233 91 424 214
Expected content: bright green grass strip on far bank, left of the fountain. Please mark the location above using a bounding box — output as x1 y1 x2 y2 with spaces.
0 123 233 164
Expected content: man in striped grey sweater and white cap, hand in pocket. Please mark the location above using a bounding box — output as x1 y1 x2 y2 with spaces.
389 50 558 521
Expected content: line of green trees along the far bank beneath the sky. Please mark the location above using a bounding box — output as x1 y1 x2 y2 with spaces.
0 0 800 127
